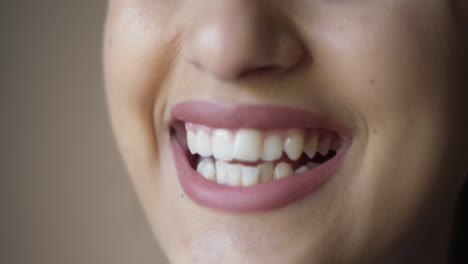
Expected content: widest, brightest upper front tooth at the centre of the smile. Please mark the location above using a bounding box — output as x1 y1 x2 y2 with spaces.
233 129 262 162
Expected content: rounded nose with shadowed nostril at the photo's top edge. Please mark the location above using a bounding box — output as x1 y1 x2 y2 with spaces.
185 0 304 80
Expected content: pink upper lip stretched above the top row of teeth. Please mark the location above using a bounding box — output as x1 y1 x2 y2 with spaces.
171 101 351 137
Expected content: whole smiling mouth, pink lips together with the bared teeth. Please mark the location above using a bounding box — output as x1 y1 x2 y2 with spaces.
171 101 351 212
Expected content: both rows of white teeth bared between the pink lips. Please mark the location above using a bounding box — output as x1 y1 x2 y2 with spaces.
186 123 341 186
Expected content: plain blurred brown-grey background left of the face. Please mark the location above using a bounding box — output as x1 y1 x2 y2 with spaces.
0 0 167 264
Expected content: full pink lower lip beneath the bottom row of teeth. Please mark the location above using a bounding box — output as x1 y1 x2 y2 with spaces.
171 137 349 212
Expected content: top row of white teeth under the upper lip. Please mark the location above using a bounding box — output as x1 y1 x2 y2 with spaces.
186 124 333 162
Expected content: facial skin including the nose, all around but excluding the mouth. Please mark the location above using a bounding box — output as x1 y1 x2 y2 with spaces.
104 0 468 264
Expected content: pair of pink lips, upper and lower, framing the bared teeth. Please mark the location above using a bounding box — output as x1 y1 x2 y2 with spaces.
171 101 350 212
